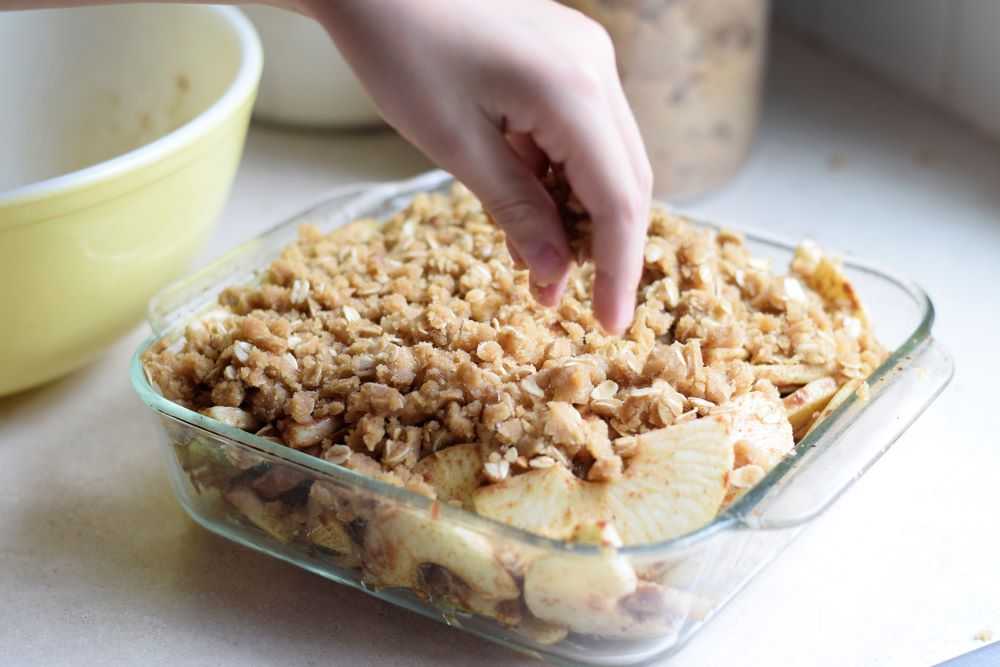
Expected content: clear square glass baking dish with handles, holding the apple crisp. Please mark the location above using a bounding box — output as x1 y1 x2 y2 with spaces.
131 172 953 665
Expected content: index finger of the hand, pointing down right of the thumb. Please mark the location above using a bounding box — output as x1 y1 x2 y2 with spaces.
535 94 650 334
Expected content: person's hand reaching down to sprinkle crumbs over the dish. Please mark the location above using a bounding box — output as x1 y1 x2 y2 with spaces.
312 0 652 333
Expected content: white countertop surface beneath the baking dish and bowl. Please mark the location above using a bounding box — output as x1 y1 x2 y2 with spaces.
0 32 1000 667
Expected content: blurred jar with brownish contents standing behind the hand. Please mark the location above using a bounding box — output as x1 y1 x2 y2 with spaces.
563 0 769 199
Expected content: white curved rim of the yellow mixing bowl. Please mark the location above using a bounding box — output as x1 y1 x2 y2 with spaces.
0 5 263 209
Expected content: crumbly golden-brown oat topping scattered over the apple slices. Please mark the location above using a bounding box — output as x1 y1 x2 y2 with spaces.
144 186 885 506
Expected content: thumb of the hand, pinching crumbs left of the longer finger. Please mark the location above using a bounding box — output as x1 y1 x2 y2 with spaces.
446 119 571 306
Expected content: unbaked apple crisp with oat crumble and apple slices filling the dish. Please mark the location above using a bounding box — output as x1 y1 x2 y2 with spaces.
143 181 886 641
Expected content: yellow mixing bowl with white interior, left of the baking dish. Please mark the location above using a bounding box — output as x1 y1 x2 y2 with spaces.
0 5 261 395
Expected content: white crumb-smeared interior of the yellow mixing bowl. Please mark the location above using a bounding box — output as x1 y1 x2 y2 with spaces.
0 5 240 193
